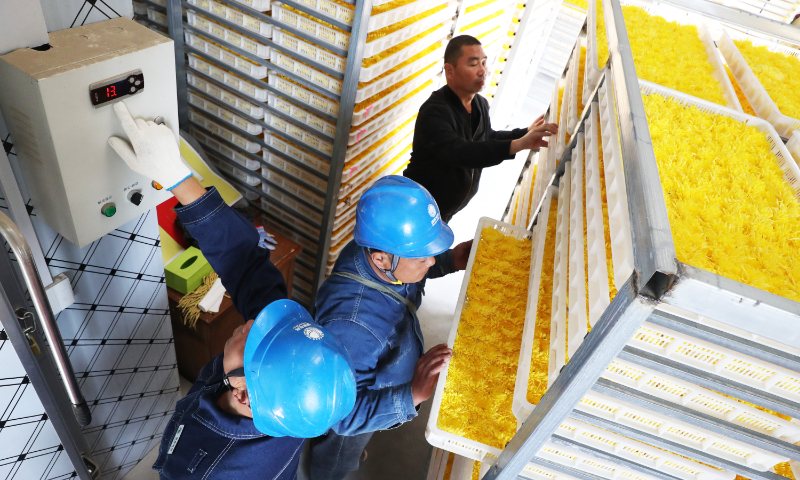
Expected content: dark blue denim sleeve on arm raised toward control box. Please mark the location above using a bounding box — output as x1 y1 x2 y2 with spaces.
175 188 287 320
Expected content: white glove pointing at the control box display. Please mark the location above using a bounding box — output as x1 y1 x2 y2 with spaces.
108 102 192 190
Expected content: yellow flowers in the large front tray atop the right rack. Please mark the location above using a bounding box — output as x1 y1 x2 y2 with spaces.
644 94 800 301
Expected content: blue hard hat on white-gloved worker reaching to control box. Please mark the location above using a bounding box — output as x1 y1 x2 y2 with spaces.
244 300 356 438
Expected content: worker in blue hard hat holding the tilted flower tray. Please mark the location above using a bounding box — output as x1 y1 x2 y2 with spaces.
310 175 472 480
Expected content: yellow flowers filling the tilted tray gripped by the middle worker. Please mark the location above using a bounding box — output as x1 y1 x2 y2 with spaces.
438 228 531 449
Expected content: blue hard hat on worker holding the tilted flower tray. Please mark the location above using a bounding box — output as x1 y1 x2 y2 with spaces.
353 175 453 258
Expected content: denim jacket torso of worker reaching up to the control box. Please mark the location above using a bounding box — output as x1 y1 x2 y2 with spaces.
153 355 306 480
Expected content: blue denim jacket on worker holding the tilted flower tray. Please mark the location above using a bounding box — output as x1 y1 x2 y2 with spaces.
316 241 456 435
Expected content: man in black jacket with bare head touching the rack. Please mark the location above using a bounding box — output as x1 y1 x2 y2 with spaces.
403 35 558 222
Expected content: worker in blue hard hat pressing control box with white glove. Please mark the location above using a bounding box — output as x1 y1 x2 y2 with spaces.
109 102 356 480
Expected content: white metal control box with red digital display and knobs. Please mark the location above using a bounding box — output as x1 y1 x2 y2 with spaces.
0 18 178 247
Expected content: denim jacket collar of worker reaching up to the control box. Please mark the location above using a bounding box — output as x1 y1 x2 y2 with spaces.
192 355 266 440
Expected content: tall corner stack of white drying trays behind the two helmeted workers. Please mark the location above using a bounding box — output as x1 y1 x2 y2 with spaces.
178 0 457 307
